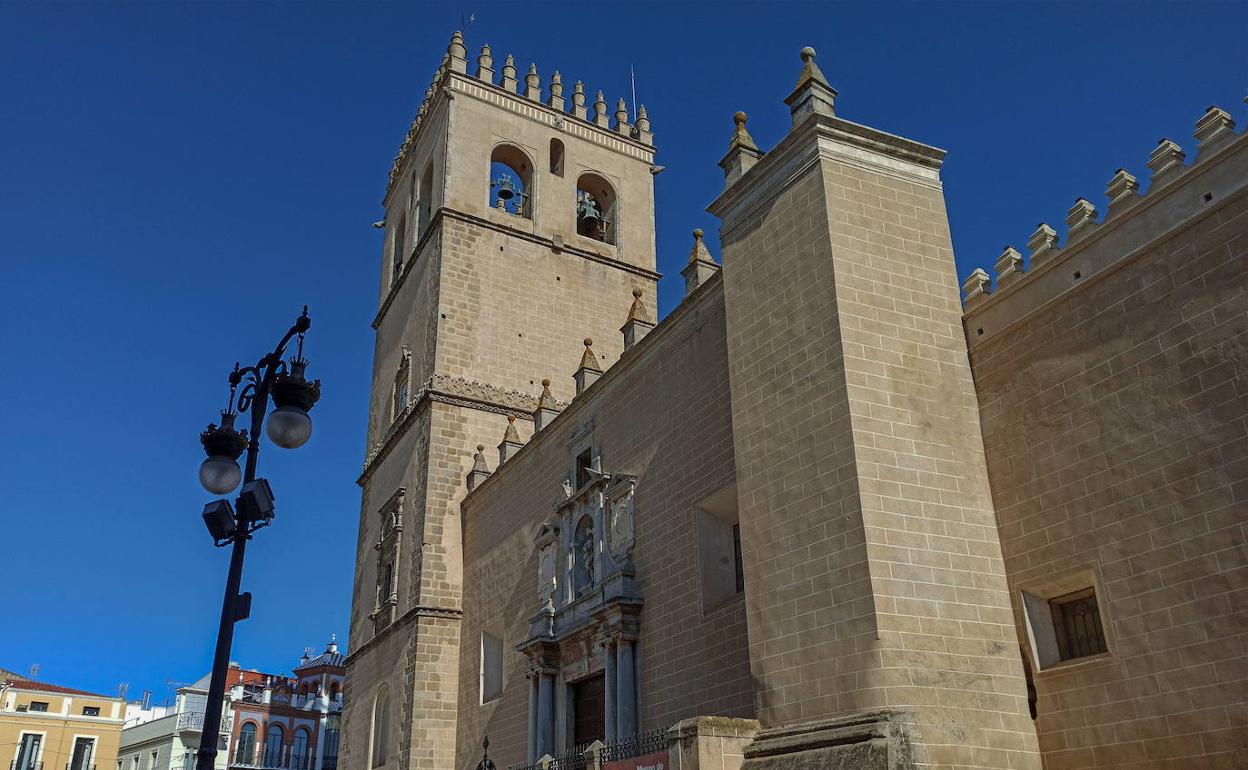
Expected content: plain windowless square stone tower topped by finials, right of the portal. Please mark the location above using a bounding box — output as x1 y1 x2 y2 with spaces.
710 49 1041 770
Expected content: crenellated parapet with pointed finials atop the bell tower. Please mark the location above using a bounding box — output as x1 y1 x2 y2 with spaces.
389 31 654 194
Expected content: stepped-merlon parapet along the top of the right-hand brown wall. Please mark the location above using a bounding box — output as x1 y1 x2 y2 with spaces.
962 100 1248 348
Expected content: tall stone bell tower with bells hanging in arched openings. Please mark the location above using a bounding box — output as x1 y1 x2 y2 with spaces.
343 32 659 770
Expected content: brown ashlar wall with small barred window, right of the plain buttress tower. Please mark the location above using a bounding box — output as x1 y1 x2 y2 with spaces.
967 136 1248 770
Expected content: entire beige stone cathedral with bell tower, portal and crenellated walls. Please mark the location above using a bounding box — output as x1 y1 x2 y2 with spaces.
341 32 1248 770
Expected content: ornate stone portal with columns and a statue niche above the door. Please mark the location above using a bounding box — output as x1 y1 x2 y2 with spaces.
517 458 643 760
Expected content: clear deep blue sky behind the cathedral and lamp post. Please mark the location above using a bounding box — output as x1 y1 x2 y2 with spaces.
0 2 1248 699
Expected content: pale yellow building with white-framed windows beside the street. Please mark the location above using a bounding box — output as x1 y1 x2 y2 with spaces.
0 676 125 770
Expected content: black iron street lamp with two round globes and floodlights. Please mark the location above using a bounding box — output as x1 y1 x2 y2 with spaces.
196 306 321 770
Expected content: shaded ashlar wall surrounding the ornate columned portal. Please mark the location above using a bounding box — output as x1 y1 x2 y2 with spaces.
456 278 753 769
